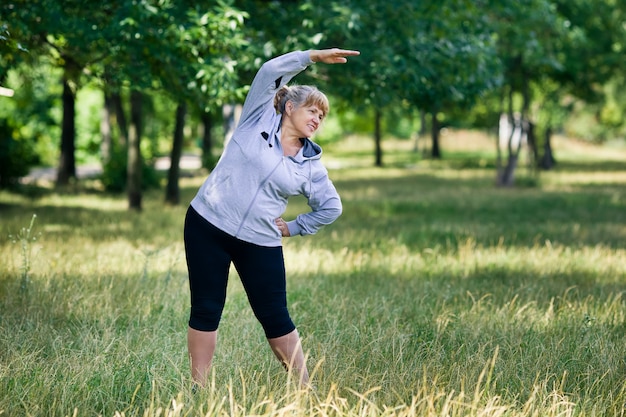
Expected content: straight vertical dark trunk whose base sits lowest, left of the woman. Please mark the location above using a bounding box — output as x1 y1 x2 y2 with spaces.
126 90 143 211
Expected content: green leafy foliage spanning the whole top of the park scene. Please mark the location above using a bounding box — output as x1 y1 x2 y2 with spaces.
0 0 626 184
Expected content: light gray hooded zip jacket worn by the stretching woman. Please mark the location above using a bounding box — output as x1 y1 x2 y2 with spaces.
191 51 342 247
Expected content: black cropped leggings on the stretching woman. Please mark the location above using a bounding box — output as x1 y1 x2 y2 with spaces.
185 206 296 338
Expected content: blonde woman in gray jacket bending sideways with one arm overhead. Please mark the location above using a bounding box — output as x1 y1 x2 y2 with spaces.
185 48 359 386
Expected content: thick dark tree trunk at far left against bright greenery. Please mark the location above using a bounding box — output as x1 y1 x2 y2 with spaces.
56 75 76 186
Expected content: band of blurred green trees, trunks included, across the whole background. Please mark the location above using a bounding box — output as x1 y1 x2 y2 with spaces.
0 0 626 203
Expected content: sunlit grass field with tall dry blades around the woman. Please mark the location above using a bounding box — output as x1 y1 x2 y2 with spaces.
0 132 626 417
